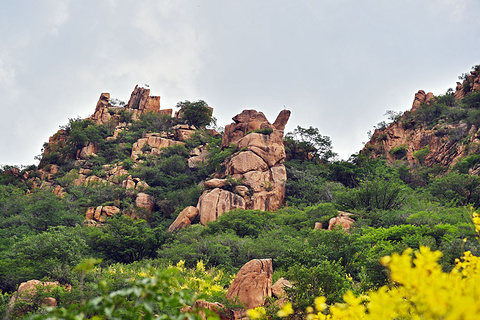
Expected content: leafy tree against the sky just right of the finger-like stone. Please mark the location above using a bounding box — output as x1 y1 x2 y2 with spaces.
285 126 336 162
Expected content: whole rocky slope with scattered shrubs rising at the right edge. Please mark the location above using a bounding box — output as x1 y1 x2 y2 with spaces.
360 68 480 167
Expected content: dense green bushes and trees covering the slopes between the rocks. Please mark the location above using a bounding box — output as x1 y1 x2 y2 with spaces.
0 67 480 319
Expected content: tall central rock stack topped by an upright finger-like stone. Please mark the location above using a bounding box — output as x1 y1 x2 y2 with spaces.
170 110 290 231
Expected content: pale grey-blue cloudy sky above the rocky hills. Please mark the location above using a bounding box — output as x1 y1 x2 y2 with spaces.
0 0 480 165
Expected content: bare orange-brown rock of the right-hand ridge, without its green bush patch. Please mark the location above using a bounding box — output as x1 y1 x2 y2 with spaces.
360 66 480 168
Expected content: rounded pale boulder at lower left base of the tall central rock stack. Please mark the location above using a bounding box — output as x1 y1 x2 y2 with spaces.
197 188 245 225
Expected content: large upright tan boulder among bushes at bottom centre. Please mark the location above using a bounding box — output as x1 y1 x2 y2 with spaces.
226 259 273 309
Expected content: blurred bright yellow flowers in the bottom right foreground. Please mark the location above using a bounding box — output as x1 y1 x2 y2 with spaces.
282 247 480 320
